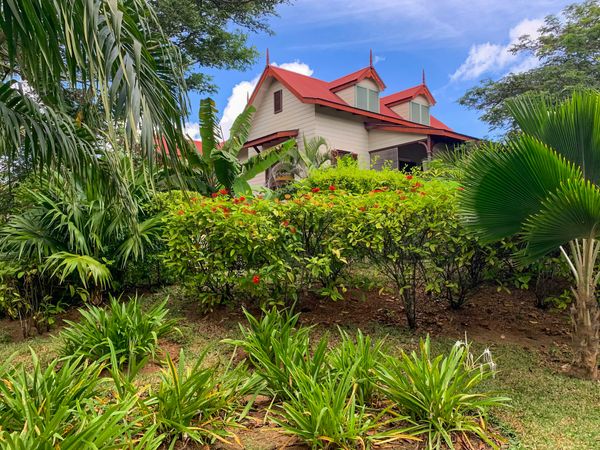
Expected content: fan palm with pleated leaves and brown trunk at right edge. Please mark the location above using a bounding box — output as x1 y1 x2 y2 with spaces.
462 92 600 378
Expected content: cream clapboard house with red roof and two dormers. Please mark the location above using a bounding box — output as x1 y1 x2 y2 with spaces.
240 54 474 184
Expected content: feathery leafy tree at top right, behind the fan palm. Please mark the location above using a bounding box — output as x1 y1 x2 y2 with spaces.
459 0 600 130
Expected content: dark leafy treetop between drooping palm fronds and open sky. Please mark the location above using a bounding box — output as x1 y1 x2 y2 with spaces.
149 0 289 92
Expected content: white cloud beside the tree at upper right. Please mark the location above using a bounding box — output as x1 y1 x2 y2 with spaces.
450 19 544 81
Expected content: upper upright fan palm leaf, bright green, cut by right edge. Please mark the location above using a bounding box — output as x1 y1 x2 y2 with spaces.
508 92 600 184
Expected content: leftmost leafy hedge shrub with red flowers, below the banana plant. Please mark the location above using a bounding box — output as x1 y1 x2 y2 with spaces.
165 195 297 309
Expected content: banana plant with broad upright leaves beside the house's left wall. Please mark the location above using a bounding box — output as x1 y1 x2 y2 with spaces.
176 98 296 195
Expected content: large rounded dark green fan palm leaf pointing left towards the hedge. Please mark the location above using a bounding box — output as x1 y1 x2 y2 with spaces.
461 136 581 241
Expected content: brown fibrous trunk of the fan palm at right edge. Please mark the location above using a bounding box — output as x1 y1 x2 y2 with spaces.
561 238 600 379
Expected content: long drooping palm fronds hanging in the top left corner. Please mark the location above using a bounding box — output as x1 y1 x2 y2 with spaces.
0 0 189 188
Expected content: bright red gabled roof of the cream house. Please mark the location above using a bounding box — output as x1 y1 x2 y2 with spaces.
248 65 475 140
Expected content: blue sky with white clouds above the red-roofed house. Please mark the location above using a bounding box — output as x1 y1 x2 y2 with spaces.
183 0 572 141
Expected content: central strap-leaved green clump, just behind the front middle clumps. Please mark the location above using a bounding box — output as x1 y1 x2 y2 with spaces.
225 307 327 397
